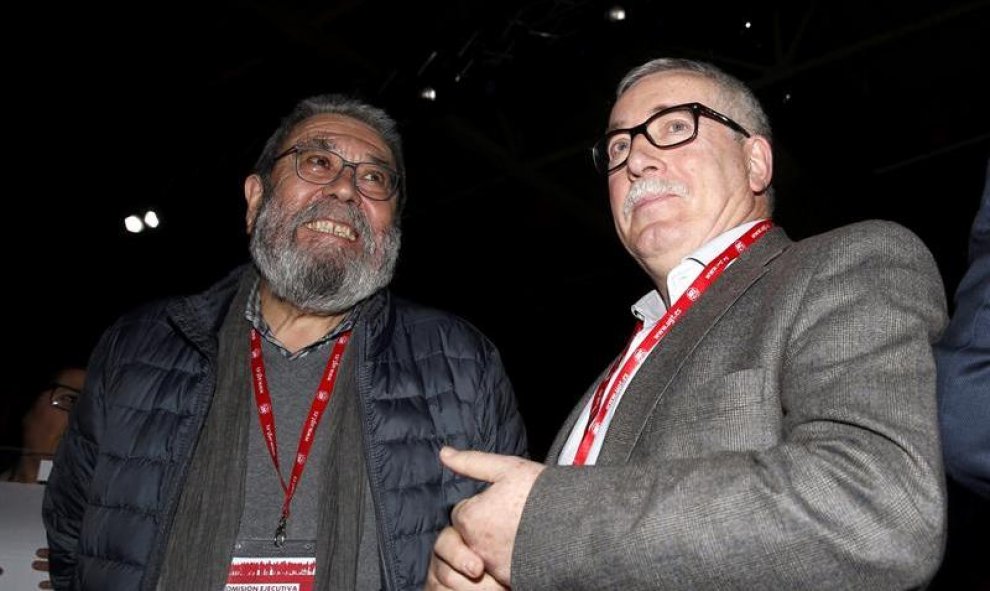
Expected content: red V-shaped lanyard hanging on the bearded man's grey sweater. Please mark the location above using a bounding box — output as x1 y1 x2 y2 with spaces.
251 329 351 547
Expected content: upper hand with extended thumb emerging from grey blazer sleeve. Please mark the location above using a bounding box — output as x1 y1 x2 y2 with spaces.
440 447 544 586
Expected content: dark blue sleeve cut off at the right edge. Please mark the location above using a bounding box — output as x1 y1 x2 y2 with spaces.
935 164 990 498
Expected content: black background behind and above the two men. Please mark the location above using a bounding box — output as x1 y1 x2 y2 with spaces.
4 0 990 588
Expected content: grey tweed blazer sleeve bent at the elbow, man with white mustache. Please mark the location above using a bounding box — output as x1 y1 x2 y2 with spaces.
512 223 946 591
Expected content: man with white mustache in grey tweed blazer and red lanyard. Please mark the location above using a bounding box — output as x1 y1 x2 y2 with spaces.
427 59 946 591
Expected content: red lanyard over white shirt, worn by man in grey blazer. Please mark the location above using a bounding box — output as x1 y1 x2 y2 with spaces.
573 220 773 466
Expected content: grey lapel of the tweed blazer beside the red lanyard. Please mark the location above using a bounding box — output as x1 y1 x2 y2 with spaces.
596 228 790 465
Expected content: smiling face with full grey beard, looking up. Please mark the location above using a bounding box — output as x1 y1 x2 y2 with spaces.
244 114 400 314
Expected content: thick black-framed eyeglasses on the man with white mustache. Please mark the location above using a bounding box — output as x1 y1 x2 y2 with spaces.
591 103 751 174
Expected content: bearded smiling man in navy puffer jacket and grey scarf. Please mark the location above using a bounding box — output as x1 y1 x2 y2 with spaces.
45 95 526 591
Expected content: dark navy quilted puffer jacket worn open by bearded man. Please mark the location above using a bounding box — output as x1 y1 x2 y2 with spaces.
44 271 526 590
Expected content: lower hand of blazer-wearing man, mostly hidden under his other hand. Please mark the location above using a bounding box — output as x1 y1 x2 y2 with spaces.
426 527 508 591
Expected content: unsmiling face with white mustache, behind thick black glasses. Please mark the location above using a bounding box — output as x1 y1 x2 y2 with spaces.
608 71 772 284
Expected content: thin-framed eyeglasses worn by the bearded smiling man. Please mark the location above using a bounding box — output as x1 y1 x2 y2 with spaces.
275 146 399 201
